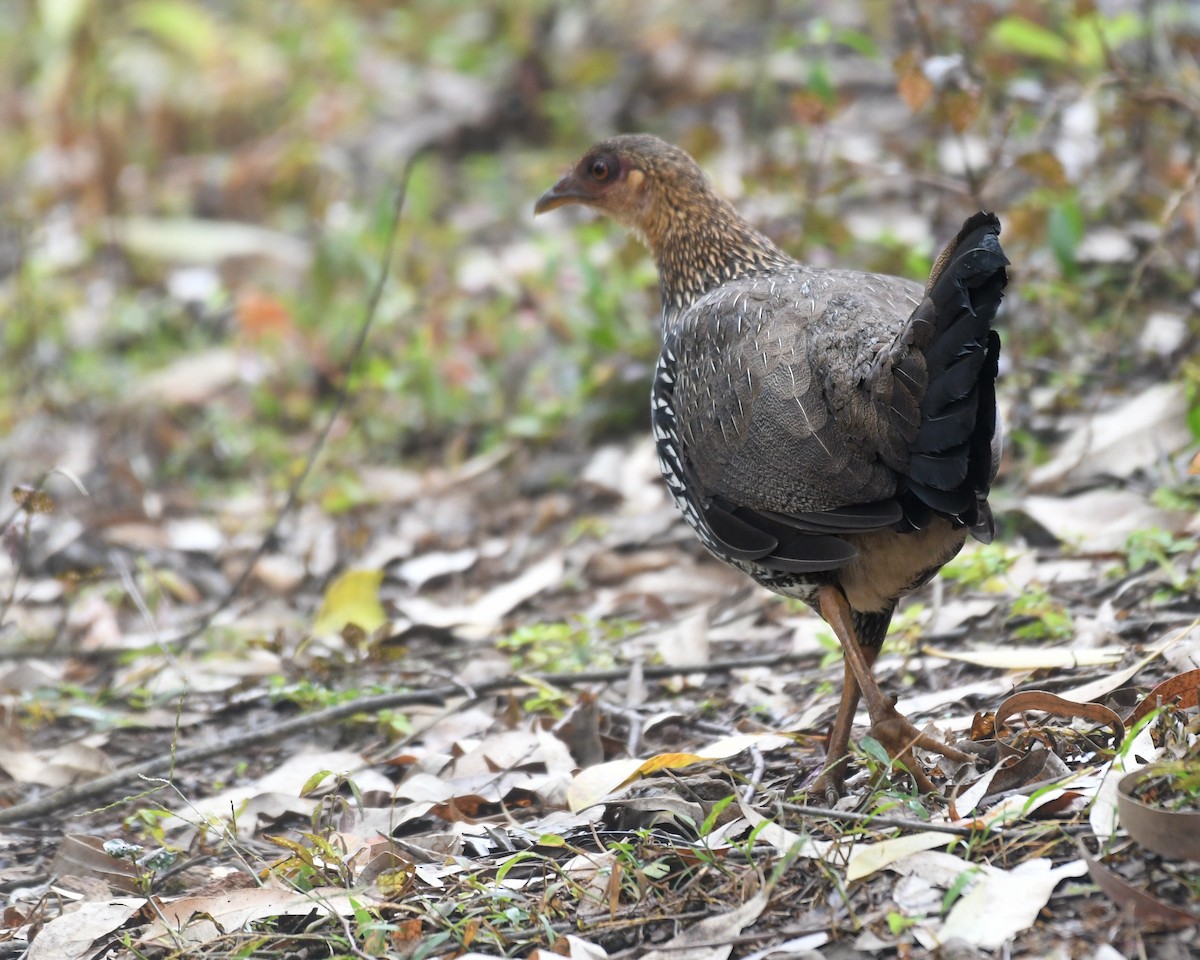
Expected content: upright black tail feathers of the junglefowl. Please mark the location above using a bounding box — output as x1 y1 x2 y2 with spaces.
904 212 1008 542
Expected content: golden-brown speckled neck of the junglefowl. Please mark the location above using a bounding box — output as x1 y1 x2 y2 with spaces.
644 192 792 329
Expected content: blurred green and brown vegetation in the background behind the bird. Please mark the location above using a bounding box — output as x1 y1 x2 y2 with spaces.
0 0 1200 504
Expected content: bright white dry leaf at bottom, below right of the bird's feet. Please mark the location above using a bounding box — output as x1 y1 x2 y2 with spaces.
914 858 1087 950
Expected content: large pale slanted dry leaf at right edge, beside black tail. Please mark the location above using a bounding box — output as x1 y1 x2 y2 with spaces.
1030 383 1192 490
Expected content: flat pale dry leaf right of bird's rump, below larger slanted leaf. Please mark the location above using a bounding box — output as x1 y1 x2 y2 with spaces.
1016 490 1192 552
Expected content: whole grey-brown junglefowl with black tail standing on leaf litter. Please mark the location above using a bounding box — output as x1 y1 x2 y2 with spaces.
534 134 1008 799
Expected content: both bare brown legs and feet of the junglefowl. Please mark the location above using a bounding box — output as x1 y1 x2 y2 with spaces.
814 584 970 799
